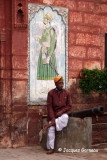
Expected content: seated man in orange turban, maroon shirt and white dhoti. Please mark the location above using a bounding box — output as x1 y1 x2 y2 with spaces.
44 76 71 154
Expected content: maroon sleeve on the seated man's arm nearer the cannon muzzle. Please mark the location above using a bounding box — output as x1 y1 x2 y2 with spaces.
62 92 72 113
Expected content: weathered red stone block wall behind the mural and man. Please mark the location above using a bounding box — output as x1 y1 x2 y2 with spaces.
0 0 107 147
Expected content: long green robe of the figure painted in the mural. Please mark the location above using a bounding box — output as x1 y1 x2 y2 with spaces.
37 27 58 80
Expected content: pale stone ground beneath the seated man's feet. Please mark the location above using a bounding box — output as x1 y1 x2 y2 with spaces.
0 146 107 160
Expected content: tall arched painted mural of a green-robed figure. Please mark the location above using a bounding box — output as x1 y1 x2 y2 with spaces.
28 3 68 105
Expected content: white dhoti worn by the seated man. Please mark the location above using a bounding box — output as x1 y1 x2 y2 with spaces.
47 113 69 149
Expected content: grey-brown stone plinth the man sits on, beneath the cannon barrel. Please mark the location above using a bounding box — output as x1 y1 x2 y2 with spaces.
42 116 92 152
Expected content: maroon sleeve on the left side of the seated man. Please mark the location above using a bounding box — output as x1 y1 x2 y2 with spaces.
47 93 55 120
